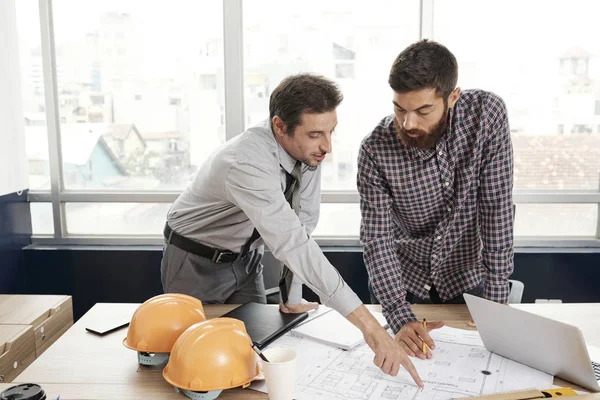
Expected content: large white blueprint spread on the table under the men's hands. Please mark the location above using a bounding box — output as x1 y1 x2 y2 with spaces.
252 327 553 400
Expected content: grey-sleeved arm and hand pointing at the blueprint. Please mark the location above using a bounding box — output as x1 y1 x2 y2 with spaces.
225 150 423 386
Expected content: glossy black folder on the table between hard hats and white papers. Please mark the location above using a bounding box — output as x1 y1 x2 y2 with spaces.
223 302 308 349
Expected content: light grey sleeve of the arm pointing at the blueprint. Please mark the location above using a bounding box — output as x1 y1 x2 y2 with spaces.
224 157 362 316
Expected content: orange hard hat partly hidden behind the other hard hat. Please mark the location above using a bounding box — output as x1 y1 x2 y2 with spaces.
123 293 206 365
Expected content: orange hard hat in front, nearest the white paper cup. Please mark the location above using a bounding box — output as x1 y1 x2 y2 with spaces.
163 318 262 398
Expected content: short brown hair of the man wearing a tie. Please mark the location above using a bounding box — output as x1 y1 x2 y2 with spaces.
269 73 344 135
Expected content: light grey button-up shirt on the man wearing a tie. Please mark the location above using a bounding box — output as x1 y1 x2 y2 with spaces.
167 120 362 316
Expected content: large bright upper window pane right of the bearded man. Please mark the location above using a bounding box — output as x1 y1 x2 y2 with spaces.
434 0 600 194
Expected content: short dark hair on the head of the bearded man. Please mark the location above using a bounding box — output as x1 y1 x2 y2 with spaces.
388 39 458 99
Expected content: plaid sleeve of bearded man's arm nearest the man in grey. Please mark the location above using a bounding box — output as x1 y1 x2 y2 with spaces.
357 142 416 333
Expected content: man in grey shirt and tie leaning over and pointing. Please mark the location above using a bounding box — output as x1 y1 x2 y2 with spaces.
161 74 422 385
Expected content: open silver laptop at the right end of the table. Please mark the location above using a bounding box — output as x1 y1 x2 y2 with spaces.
463 294 600 392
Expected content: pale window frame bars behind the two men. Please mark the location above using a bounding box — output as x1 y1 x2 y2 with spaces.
28 0 600 248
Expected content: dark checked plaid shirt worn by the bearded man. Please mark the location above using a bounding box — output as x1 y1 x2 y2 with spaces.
357 90 513 332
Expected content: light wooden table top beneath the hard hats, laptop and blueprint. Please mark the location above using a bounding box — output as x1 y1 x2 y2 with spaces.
0 303 600 400
